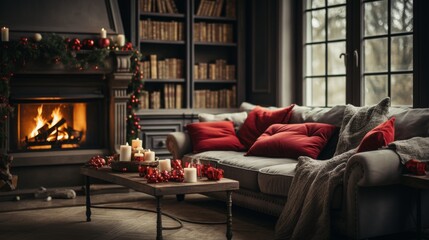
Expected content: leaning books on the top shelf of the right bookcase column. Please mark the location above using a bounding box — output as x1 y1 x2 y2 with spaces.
196 0 236 17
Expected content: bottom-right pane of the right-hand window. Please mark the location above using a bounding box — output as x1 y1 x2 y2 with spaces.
391 74 413 106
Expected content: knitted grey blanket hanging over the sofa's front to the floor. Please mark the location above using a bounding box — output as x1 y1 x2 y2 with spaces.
275 148 356 240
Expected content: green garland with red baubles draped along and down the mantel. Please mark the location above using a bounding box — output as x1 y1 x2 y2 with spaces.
0 34 143 153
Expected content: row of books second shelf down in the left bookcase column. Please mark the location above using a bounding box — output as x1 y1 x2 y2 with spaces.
140 19 184 41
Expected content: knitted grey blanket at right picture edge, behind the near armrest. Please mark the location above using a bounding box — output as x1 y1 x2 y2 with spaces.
387 137 429 164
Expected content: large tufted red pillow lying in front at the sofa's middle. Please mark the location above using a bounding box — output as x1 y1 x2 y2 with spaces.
246 123 336 159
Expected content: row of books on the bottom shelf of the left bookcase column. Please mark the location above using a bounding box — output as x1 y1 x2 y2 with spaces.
140 83 183 109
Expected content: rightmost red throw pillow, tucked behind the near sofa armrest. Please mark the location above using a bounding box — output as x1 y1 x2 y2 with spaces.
357 117 395 152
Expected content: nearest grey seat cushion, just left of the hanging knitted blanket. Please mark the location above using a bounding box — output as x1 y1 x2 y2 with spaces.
258 163 297 197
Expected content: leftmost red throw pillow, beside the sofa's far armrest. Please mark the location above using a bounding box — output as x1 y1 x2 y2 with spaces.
186 121 244 153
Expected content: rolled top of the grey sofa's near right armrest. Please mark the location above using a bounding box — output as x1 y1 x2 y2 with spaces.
346 149 402 187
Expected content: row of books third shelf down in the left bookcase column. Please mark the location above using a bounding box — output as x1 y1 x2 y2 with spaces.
139 54 184 79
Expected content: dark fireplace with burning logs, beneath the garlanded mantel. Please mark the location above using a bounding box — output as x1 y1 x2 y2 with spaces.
8 70 122 189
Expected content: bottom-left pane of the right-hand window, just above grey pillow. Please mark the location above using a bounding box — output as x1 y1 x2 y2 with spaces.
365 75 388 105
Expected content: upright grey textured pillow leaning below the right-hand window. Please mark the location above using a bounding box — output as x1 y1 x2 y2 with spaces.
334 98 390 156
